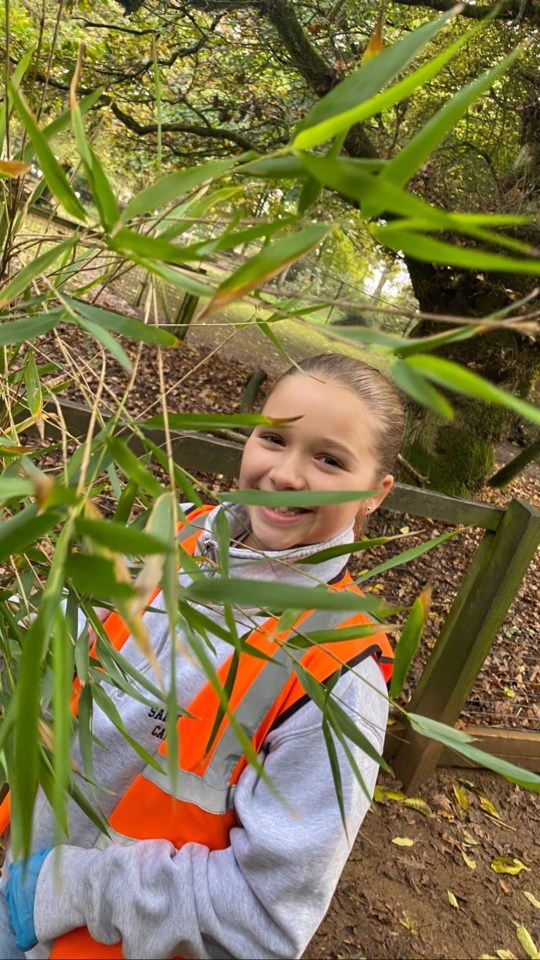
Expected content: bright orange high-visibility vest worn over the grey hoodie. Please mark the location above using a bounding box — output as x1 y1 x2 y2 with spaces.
0 507 393 960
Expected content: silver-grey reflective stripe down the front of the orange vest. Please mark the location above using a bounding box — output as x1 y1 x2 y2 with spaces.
141 610 368 814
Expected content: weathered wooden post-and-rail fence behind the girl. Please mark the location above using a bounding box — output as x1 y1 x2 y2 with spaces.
21 401 540 790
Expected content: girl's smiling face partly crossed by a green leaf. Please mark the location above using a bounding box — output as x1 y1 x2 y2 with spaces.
239 373 394 550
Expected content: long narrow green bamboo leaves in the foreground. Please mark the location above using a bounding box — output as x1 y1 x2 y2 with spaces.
0 12 538 851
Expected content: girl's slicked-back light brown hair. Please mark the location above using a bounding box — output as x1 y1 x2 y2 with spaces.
266 353 405 480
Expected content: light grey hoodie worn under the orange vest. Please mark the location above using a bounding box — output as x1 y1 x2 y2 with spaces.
19 508 388 960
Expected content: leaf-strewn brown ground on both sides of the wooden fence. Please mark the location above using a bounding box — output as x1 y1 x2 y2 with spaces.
35 304 540 960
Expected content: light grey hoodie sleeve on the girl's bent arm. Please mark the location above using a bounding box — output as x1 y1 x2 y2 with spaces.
35 658 388 960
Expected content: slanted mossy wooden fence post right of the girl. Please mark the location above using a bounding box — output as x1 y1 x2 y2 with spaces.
392 500 540 792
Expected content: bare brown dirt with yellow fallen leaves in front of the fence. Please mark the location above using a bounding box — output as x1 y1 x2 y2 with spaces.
304 768 540 960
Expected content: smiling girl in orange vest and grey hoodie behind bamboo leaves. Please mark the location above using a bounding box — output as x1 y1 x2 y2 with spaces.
0 355 404 958
